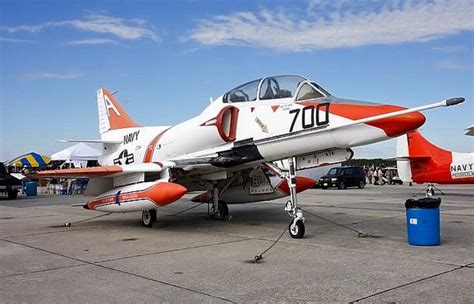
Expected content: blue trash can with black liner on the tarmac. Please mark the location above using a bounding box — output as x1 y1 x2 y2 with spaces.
405 197 441 246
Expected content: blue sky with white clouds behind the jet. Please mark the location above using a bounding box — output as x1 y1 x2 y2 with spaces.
0 0 474 160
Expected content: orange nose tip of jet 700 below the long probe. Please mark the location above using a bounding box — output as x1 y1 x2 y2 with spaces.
369 112 426 137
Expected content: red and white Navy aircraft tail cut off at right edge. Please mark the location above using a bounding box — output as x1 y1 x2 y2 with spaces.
397 131 474 184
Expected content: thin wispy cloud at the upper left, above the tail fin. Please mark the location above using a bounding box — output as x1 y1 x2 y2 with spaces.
0 14 160 42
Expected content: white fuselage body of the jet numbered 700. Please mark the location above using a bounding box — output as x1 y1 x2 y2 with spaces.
99 97 387 171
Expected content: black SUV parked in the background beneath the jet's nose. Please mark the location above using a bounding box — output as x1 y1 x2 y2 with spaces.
318 167 365 189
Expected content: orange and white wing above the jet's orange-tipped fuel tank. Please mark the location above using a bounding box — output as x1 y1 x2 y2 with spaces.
30 163 167 178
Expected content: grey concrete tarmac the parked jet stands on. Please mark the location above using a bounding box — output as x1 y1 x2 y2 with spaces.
0 185 474 303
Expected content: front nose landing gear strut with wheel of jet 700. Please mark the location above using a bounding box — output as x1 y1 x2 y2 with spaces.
285 157 305 239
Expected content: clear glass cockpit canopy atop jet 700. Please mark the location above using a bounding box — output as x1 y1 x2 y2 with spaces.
222 75 331 103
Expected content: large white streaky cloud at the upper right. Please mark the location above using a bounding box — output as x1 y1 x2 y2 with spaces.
185 0 474 52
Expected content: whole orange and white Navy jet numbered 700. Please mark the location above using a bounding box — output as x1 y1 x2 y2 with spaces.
38 75 464 238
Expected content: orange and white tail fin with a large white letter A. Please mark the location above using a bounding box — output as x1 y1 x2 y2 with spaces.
97 89 140 135
